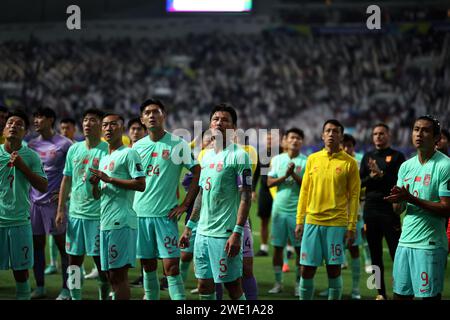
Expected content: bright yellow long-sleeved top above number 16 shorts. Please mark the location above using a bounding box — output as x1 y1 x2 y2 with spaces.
297 149 361 231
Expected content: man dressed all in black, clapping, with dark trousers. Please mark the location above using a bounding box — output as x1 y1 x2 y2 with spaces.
359 123 405 300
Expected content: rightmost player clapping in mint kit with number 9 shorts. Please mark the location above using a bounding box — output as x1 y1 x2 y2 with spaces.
385 115 450 300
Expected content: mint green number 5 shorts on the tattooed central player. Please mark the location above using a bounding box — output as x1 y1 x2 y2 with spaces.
194 234 242 283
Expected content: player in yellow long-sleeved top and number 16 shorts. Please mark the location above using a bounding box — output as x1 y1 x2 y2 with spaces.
295 119 361 300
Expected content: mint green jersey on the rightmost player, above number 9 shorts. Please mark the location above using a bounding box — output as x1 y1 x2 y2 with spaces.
397 151 450 250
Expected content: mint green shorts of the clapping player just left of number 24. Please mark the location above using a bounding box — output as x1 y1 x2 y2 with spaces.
100 227 137 271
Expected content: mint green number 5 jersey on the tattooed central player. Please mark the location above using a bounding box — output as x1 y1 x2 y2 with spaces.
197 144 252 238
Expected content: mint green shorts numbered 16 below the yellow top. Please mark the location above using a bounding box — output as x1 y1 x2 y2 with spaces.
300 224 347 267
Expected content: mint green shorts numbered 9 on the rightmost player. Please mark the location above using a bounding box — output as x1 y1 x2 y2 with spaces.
392 246 447 298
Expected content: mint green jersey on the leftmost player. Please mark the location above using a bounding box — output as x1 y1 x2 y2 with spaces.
0 144 47 227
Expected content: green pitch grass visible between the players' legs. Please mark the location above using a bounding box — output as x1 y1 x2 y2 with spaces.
0 180 450 300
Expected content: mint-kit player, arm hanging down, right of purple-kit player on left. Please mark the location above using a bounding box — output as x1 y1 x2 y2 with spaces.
56 109 109 300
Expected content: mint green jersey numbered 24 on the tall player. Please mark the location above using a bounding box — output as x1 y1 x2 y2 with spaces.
133 132 198 217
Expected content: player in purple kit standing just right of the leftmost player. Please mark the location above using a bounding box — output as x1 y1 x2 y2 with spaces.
28 108 72 300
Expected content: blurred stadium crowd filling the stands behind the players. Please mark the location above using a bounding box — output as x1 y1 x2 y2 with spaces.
0 29 450 147
